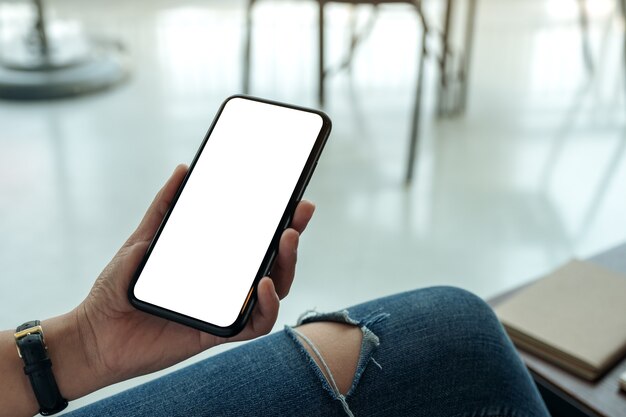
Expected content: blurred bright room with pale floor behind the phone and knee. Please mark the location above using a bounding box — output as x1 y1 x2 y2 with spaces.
0 0 626 408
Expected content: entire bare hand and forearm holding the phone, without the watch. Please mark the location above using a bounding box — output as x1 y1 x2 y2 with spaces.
0 165 314 417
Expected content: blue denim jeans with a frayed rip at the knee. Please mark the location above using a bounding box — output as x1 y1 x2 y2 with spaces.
67 287 549 417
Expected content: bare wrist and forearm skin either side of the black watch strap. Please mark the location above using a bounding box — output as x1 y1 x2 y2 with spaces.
0 312 103 416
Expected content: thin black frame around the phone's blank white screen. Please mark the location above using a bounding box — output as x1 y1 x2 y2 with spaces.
128 94 332 337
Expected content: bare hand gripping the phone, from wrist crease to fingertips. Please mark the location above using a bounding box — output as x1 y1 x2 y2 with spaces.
74 165 314 386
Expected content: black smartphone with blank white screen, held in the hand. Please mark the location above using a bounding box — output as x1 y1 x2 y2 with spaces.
128 95 331 337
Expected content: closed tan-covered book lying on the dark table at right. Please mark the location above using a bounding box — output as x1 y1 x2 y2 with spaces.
495 260 626 381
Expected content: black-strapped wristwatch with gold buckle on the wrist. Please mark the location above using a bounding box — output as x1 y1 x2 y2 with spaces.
14 320 67 416
